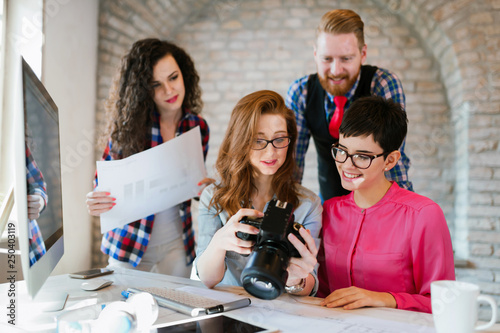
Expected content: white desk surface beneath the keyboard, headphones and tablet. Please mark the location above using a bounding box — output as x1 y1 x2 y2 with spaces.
0 270 500 333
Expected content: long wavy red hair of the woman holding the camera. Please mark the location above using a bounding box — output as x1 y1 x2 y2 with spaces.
210 90 299 215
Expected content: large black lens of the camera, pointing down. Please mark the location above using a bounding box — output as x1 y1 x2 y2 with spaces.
241 243 290 299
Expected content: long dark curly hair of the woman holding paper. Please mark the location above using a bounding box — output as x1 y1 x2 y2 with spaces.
103 38 203 157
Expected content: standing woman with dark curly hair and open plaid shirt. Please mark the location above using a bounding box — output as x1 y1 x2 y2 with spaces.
87 38 211 277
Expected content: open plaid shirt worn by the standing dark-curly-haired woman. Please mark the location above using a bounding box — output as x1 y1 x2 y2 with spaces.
94 111 209 267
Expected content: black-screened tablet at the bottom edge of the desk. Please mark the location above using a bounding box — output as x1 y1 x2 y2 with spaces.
156 314 279 333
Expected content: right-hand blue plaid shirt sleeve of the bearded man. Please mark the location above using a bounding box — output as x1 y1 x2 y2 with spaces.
371 68 413 191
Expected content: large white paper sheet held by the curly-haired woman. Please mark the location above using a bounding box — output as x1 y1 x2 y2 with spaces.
97 126 207 233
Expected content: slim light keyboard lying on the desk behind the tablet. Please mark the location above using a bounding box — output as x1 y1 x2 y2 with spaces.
128 287 221 317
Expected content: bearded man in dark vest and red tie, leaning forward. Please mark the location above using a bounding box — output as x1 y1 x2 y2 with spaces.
286 9 413 201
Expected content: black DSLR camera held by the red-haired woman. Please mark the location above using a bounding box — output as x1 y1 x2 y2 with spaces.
236 199 304 299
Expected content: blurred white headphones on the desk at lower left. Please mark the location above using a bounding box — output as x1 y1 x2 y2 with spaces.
57 293 158 333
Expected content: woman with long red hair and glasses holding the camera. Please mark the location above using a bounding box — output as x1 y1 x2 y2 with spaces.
195 90 322 295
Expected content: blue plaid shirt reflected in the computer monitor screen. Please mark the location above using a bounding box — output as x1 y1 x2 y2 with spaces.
26 145 48 266
